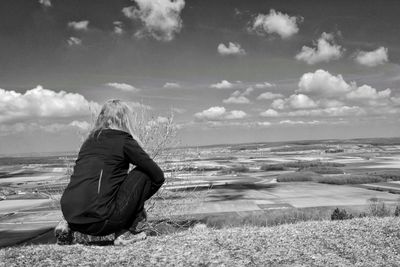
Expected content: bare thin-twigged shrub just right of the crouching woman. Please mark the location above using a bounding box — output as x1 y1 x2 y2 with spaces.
128 105 208 227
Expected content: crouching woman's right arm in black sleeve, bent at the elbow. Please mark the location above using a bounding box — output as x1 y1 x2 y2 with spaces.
124 136 165 199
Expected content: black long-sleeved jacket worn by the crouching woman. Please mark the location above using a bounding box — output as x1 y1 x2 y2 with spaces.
61 129 164 224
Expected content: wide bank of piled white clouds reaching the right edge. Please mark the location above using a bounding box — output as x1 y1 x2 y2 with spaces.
260 70 400 120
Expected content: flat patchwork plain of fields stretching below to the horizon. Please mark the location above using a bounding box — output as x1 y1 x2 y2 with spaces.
0 138 400 246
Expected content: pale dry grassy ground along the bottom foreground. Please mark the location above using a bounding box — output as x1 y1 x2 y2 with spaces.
0 217 400 266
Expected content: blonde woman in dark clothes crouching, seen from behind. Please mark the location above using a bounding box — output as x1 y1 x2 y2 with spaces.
55 100 164 245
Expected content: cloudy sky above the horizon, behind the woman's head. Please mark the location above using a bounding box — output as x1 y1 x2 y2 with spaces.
0 0 400 154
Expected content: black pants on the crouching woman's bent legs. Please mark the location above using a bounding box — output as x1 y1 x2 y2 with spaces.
69 169 155 236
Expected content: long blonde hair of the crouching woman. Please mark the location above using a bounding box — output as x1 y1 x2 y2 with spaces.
89 99 142 145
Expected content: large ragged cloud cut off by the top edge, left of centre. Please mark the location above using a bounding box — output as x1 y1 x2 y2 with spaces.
122 0 185 42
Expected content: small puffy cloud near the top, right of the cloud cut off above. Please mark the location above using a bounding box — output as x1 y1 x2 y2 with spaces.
251 9 300 39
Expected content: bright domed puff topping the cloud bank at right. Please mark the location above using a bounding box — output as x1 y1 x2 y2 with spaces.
297 69 351 96
